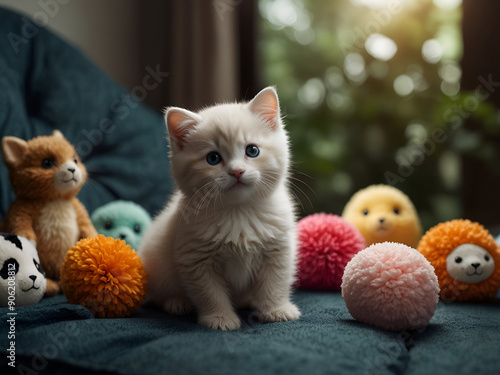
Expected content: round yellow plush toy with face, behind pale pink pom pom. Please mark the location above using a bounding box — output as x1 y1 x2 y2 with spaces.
342 185 422 248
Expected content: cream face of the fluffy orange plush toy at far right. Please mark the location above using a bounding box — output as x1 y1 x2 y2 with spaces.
446 243 495 284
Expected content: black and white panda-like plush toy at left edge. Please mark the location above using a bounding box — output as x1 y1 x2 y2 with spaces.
0 233 47 308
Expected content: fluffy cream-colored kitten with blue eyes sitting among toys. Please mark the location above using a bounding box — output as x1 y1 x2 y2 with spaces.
140 87 300 330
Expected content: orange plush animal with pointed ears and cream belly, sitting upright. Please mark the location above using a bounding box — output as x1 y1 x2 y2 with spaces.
2 130 97 296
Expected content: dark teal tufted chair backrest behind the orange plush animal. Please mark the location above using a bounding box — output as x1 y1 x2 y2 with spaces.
0 8 172 219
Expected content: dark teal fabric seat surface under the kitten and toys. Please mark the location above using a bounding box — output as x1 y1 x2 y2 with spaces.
0 290 500 375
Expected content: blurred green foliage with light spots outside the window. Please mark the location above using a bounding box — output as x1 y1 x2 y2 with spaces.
259 0 500 229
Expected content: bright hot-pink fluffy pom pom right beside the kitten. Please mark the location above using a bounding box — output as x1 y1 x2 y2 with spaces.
297 213 366 290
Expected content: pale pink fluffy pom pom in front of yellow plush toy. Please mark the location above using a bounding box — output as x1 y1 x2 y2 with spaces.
342 242 439 331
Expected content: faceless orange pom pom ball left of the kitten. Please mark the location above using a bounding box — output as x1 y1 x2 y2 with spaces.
61 234 147 318
